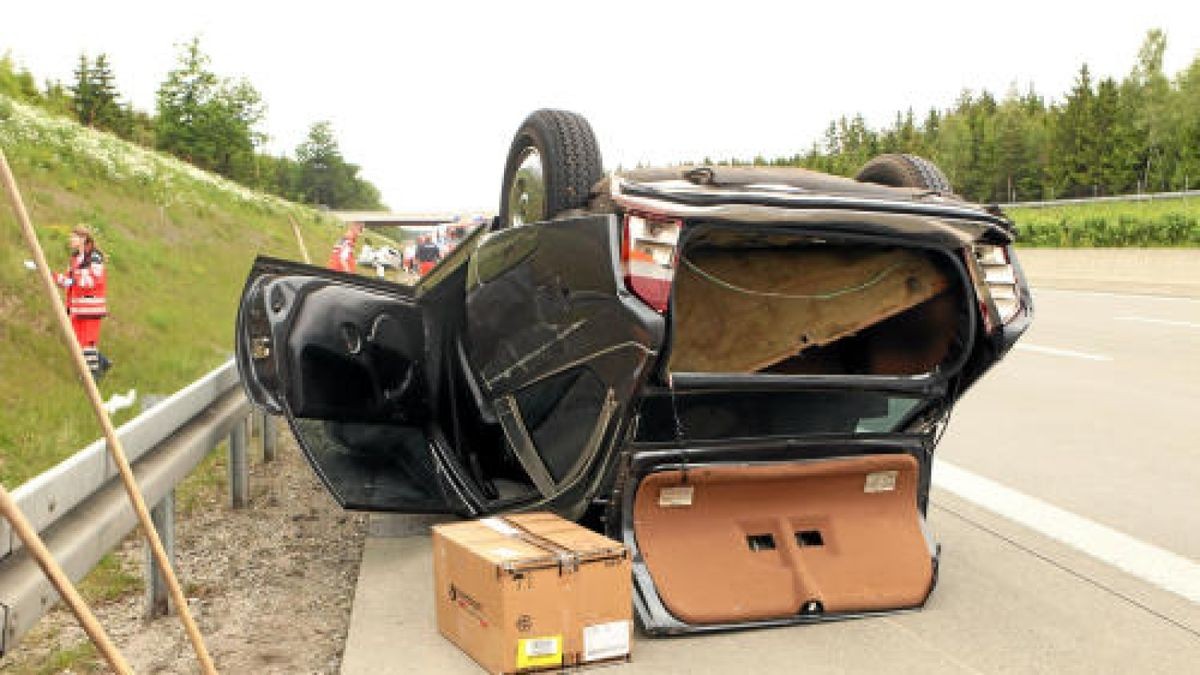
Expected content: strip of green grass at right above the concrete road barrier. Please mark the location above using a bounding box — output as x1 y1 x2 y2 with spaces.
1008 198 1200 249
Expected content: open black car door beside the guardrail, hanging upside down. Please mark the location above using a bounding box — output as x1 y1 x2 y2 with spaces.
236 257 464 513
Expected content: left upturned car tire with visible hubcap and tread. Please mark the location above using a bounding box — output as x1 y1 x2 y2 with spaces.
499 109 604 228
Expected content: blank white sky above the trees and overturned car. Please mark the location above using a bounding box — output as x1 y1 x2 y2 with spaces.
0 0 1200 211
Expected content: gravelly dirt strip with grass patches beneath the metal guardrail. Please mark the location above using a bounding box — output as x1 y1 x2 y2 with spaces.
0 431 366 674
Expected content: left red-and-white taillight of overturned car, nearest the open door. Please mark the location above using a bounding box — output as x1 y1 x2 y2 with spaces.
620 214 683 312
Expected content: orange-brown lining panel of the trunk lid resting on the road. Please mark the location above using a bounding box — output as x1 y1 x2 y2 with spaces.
634 454 932 623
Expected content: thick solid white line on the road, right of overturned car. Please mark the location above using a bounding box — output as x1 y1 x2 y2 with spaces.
934 460 1200 603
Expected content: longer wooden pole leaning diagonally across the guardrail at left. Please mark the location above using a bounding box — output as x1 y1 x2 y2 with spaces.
0 150 217 674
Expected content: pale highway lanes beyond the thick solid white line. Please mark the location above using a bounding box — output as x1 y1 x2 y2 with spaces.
937 291 1200 560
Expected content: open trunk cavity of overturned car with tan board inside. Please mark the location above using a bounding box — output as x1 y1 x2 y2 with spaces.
670 246 956 375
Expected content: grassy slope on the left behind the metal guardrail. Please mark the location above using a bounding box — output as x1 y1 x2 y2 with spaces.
0 96 357 488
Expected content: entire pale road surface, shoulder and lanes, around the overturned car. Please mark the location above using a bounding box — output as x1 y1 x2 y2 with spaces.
342 285 1200 674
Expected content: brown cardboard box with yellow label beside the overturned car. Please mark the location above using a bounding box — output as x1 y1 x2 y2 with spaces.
433 513 632 674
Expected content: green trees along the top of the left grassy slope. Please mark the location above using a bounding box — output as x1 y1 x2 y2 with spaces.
0 38 384 209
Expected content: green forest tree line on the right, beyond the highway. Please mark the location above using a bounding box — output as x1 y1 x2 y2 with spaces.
706 30 1200 202
